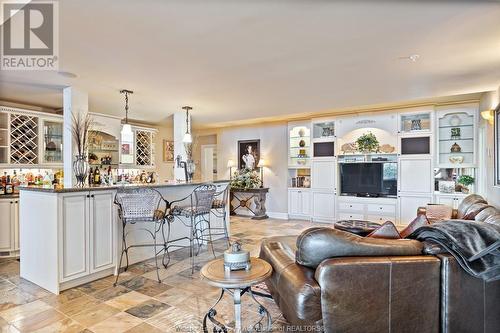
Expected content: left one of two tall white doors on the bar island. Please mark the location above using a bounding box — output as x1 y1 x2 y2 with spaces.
61 193 89 281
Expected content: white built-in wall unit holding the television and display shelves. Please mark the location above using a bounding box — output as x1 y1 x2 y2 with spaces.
288 103 478 224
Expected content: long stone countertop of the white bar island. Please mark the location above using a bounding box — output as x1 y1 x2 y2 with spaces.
19 179 229 193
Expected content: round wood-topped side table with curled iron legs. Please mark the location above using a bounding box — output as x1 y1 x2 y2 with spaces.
200 258 273 333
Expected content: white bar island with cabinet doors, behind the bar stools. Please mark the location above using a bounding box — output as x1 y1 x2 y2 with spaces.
19 180 229 294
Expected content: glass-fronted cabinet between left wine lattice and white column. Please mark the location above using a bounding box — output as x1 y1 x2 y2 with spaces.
42 120 63 164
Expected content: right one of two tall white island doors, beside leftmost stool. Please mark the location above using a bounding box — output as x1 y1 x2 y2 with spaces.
90 191 116 273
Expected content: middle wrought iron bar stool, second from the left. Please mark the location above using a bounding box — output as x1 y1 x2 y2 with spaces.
165 184 217 273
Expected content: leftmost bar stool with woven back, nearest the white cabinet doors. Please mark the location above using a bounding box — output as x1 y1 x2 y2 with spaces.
113 188 168 286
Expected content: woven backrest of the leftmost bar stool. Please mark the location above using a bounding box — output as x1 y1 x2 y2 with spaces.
115 188 164 223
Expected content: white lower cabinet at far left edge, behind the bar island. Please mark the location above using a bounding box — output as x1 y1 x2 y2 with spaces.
0 198 19 256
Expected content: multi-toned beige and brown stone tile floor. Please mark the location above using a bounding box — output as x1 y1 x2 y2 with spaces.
0 217 322 333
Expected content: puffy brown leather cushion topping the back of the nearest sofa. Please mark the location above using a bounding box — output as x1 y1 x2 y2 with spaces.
295 227 422 268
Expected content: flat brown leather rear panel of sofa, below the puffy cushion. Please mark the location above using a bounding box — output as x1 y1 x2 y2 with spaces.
315 256 440 333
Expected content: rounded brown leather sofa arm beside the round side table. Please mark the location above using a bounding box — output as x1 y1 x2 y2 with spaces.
260 236 321 326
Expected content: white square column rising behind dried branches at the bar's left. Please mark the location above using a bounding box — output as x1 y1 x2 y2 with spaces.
63 87 89 187
